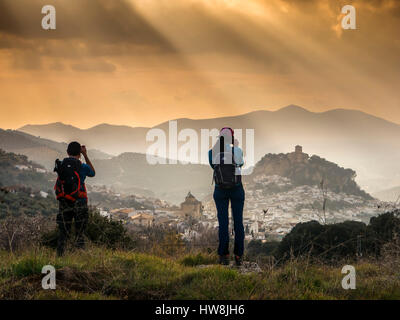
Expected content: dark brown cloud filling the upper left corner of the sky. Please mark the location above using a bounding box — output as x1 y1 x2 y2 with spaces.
0 0 174 52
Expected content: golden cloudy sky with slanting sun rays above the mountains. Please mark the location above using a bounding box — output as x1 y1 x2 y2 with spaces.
0 0 400 129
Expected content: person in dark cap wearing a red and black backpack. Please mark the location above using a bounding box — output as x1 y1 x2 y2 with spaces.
54 141 96 256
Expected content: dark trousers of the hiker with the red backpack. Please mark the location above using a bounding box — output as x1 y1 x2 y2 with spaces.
57 200 89 256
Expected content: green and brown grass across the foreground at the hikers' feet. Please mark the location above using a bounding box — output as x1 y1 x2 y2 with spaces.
0 247 400 300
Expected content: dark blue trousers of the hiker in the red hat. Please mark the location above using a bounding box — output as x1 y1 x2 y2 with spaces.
214 184 245 256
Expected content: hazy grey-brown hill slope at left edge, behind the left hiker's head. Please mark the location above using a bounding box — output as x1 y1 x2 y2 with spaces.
0 129 110 170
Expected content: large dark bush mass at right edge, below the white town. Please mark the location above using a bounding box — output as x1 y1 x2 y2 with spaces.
276 210 400 261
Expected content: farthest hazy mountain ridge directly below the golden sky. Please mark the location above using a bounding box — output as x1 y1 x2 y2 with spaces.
20 105 400 192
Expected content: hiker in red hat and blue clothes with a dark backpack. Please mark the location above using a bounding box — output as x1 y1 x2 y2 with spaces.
208 127 245 266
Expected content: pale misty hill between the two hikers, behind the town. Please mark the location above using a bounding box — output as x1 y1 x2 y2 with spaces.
88 153 212 203
